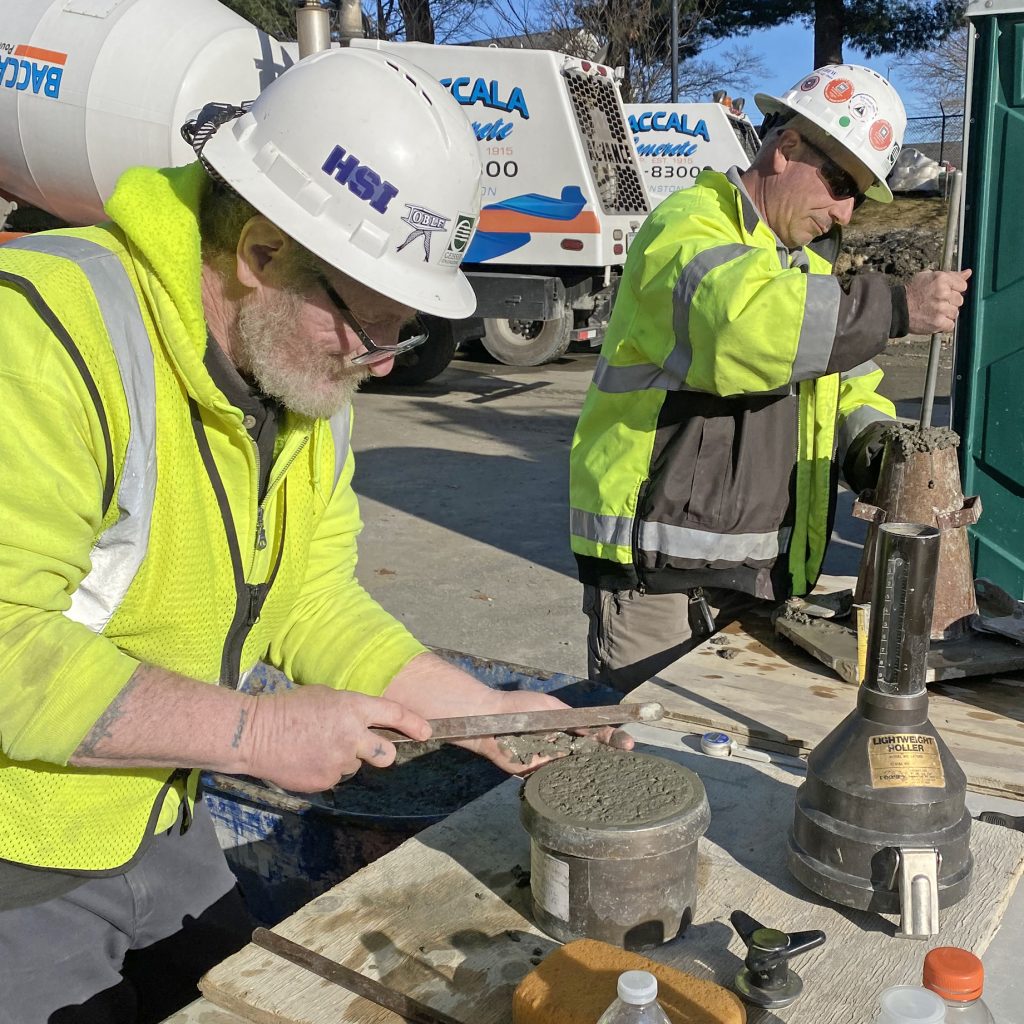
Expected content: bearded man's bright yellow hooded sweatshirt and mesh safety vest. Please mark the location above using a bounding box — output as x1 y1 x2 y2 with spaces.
0 164 425 873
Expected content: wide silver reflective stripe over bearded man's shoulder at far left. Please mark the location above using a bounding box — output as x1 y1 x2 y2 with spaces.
7 236 157 633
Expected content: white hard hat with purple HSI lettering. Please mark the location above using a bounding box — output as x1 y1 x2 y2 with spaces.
196 49 481 319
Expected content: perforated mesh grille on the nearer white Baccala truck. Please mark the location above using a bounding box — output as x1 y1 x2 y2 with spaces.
564 68 649 216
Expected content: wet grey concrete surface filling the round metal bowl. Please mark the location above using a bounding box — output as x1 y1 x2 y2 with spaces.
538 750 690 825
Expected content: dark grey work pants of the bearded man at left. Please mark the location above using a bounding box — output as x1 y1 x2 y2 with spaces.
0 803 252 1024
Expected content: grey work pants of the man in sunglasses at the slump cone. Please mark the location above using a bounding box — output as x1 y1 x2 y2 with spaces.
583 585 761 693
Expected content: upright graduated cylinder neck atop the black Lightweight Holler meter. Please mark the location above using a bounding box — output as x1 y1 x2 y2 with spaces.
864 522 940 696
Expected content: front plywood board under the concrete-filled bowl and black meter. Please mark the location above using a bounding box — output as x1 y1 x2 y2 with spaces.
197 727 1024 1024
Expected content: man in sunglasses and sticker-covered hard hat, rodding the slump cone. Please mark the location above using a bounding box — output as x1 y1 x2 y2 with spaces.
569 65 970 690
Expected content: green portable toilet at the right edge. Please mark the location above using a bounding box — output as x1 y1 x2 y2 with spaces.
952 0 1024 598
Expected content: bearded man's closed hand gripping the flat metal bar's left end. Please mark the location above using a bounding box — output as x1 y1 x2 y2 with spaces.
242 686 430 793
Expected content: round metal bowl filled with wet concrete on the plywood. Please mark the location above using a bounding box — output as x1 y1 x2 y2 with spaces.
521 751 711 949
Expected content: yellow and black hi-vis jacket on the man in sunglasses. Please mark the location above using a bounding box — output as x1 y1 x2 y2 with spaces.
569 168 895 599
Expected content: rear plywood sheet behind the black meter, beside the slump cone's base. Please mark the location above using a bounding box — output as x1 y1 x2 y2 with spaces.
629 615 1024 799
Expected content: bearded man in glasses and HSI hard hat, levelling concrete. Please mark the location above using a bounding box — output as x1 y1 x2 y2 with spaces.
0 50 622 1024
